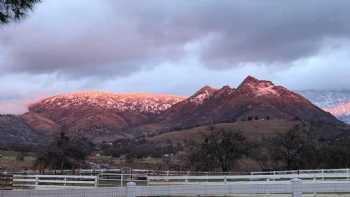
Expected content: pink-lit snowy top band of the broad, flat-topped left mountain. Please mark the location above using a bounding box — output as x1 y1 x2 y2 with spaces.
29 91 185 114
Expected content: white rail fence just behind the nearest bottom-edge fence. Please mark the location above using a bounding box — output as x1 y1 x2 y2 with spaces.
9 169 350 188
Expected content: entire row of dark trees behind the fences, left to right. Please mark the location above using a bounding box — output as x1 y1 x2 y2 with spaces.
35 123 350 171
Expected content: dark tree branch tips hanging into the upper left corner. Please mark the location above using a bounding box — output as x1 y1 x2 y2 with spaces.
0 0 41 24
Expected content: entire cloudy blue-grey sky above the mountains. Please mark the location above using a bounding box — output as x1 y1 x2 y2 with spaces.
0 0 350 113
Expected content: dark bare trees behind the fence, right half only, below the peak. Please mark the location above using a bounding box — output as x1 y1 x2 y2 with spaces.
188 124 350 171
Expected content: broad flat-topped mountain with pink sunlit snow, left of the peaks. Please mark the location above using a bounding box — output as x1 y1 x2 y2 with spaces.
23 91 185 141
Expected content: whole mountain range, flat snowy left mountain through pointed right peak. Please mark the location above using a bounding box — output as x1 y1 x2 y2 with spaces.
0 76 344 143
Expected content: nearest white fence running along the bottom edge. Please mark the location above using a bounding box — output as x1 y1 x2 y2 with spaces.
0 179 350 197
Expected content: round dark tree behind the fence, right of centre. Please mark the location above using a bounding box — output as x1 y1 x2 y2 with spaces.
188 128 250 172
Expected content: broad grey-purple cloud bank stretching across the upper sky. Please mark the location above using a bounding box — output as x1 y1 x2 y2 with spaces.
0 0 350 77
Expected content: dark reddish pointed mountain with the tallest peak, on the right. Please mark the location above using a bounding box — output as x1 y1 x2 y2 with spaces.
158 76 340 128
